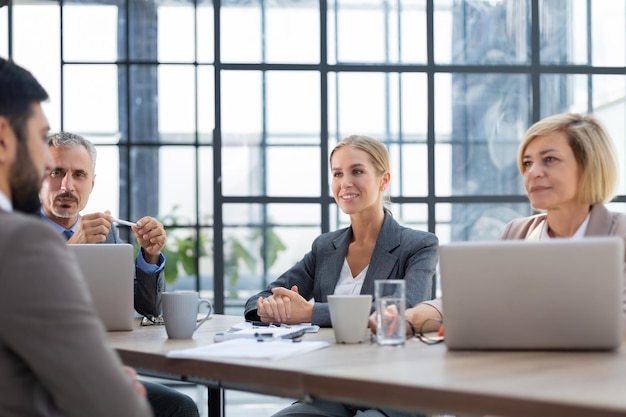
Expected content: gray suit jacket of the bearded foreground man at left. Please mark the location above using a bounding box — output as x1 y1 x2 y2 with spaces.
0 210 152 417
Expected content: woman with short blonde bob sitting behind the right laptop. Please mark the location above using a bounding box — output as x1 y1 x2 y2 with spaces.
398 113 626 330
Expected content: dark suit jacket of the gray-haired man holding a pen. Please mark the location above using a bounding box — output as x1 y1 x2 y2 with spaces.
103 224 165 317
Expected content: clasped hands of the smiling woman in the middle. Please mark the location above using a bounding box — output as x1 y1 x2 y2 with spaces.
256 285 313 324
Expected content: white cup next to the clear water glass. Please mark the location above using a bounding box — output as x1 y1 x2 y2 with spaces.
328 294 372 343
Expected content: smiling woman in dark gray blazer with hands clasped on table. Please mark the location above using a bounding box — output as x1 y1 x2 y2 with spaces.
245 136 438 417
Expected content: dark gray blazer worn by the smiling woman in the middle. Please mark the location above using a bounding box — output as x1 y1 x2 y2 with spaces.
244 214 439 327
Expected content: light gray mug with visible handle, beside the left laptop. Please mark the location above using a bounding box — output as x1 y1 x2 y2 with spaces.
161 291 213 339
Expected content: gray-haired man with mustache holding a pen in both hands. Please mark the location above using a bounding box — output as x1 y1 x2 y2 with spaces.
40 132 199 417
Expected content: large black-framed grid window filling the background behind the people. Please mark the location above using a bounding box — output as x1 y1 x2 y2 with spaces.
0 0 626 313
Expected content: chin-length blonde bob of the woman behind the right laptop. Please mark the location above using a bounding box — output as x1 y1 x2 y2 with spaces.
517 113 618 205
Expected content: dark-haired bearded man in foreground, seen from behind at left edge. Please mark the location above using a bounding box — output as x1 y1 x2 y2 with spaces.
0 58 151 417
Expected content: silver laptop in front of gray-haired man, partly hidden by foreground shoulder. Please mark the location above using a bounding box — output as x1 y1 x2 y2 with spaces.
68 243 135 331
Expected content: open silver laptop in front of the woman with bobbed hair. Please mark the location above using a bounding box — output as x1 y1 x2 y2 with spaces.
439 237 624 350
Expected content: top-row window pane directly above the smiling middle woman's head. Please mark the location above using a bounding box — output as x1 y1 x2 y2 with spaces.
328 0 426 64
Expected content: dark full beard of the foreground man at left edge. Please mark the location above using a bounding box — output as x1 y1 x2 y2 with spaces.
9 140 42 215
